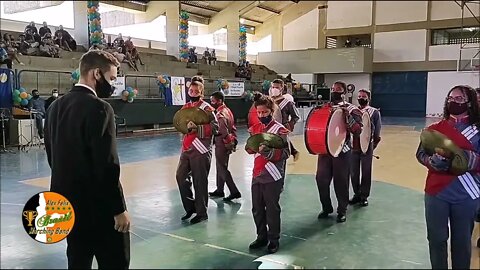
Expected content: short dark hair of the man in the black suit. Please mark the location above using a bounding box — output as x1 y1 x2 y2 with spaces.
79 50 120 76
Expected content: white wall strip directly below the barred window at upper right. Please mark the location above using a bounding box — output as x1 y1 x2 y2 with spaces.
428 43 480 61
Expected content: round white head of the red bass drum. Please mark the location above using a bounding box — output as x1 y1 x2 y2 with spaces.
326 109 347 157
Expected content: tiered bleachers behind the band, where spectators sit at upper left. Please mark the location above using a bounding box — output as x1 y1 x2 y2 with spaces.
14 44 277 95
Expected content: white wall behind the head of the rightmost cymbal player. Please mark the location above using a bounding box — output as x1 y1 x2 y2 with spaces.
426 71 480 117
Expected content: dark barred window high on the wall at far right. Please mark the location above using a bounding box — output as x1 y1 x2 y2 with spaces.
432 27 480 45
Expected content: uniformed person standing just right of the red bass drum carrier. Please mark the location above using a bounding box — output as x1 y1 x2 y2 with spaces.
349 89 382 206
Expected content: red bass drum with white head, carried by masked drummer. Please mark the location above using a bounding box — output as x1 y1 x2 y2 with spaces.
305 104 347 157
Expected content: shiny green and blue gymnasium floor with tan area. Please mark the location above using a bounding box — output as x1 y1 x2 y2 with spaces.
0 119 480 269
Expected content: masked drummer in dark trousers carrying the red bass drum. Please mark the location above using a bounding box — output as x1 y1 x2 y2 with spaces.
315 81 362 223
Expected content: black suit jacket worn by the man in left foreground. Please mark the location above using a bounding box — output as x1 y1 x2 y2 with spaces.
45 86 126 234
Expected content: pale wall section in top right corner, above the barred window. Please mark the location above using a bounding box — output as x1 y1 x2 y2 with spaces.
431 1 480 20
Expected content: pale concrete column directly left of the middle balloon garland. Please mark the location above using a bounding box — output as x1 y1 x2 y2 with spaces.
165 1 180 58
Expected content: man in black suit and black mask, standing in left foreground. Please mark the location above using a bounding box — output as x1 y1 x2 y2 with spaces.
45 50 130 269
